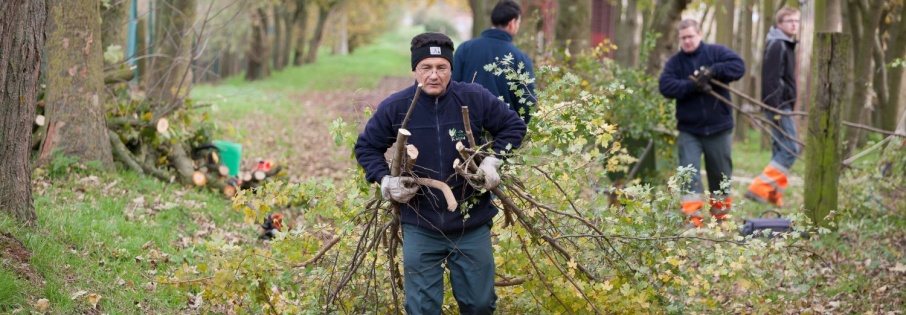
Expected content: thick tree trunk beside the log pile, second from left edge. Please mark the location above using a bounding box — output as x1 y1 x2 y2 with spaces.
39 0 113 169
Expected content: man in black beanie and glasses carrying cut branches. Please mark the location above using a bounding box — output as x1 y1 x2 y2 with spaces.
355 33 526 314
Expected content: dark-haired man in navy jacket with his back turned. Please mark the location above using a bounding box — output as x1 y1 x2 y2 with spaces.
453 0 536 123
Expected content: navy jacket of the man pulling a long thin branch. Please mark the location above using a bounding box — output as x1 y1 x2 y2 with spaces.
658 43 746 136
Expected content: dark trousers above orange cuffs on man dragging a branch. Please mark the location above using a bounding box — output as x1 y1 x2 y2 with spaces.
676 129 733 195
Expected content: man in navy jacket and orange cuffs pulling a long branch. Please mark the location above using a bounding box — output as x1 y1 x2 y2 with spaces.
658 20 746 227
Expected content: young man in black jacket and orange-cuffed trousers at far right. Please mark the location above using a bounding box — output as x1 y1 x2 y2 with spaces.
746 7 799 207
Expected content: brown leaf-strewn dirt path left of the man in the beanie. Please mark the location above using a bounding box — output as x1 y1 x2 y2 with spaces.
228 77 413 182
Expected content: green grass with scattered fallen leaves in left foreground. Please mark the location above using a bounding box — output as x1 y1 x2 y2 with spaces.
0 170 240 314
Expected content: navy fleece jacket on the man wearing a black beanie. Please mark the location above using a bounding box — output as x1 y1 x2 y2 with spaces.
355 81 526 234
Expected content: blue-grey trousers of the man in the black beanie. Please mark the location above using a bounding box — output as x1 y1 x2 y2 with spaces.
403 222 497 315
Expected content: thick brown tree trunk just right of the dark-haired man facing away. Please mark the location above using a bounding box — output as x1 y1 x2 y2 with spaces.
554 0 591 54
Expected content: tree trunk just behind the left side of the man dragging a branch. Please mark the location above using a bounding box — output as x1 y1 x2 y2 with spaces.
645 0 689 75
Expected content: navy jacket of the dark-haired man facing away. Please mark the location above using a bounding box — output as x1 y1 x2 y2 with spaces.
452 28 537 123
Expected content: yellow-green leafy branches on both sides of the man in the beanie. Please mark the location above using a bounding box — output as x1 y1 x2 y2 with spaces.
162 58 828 314
